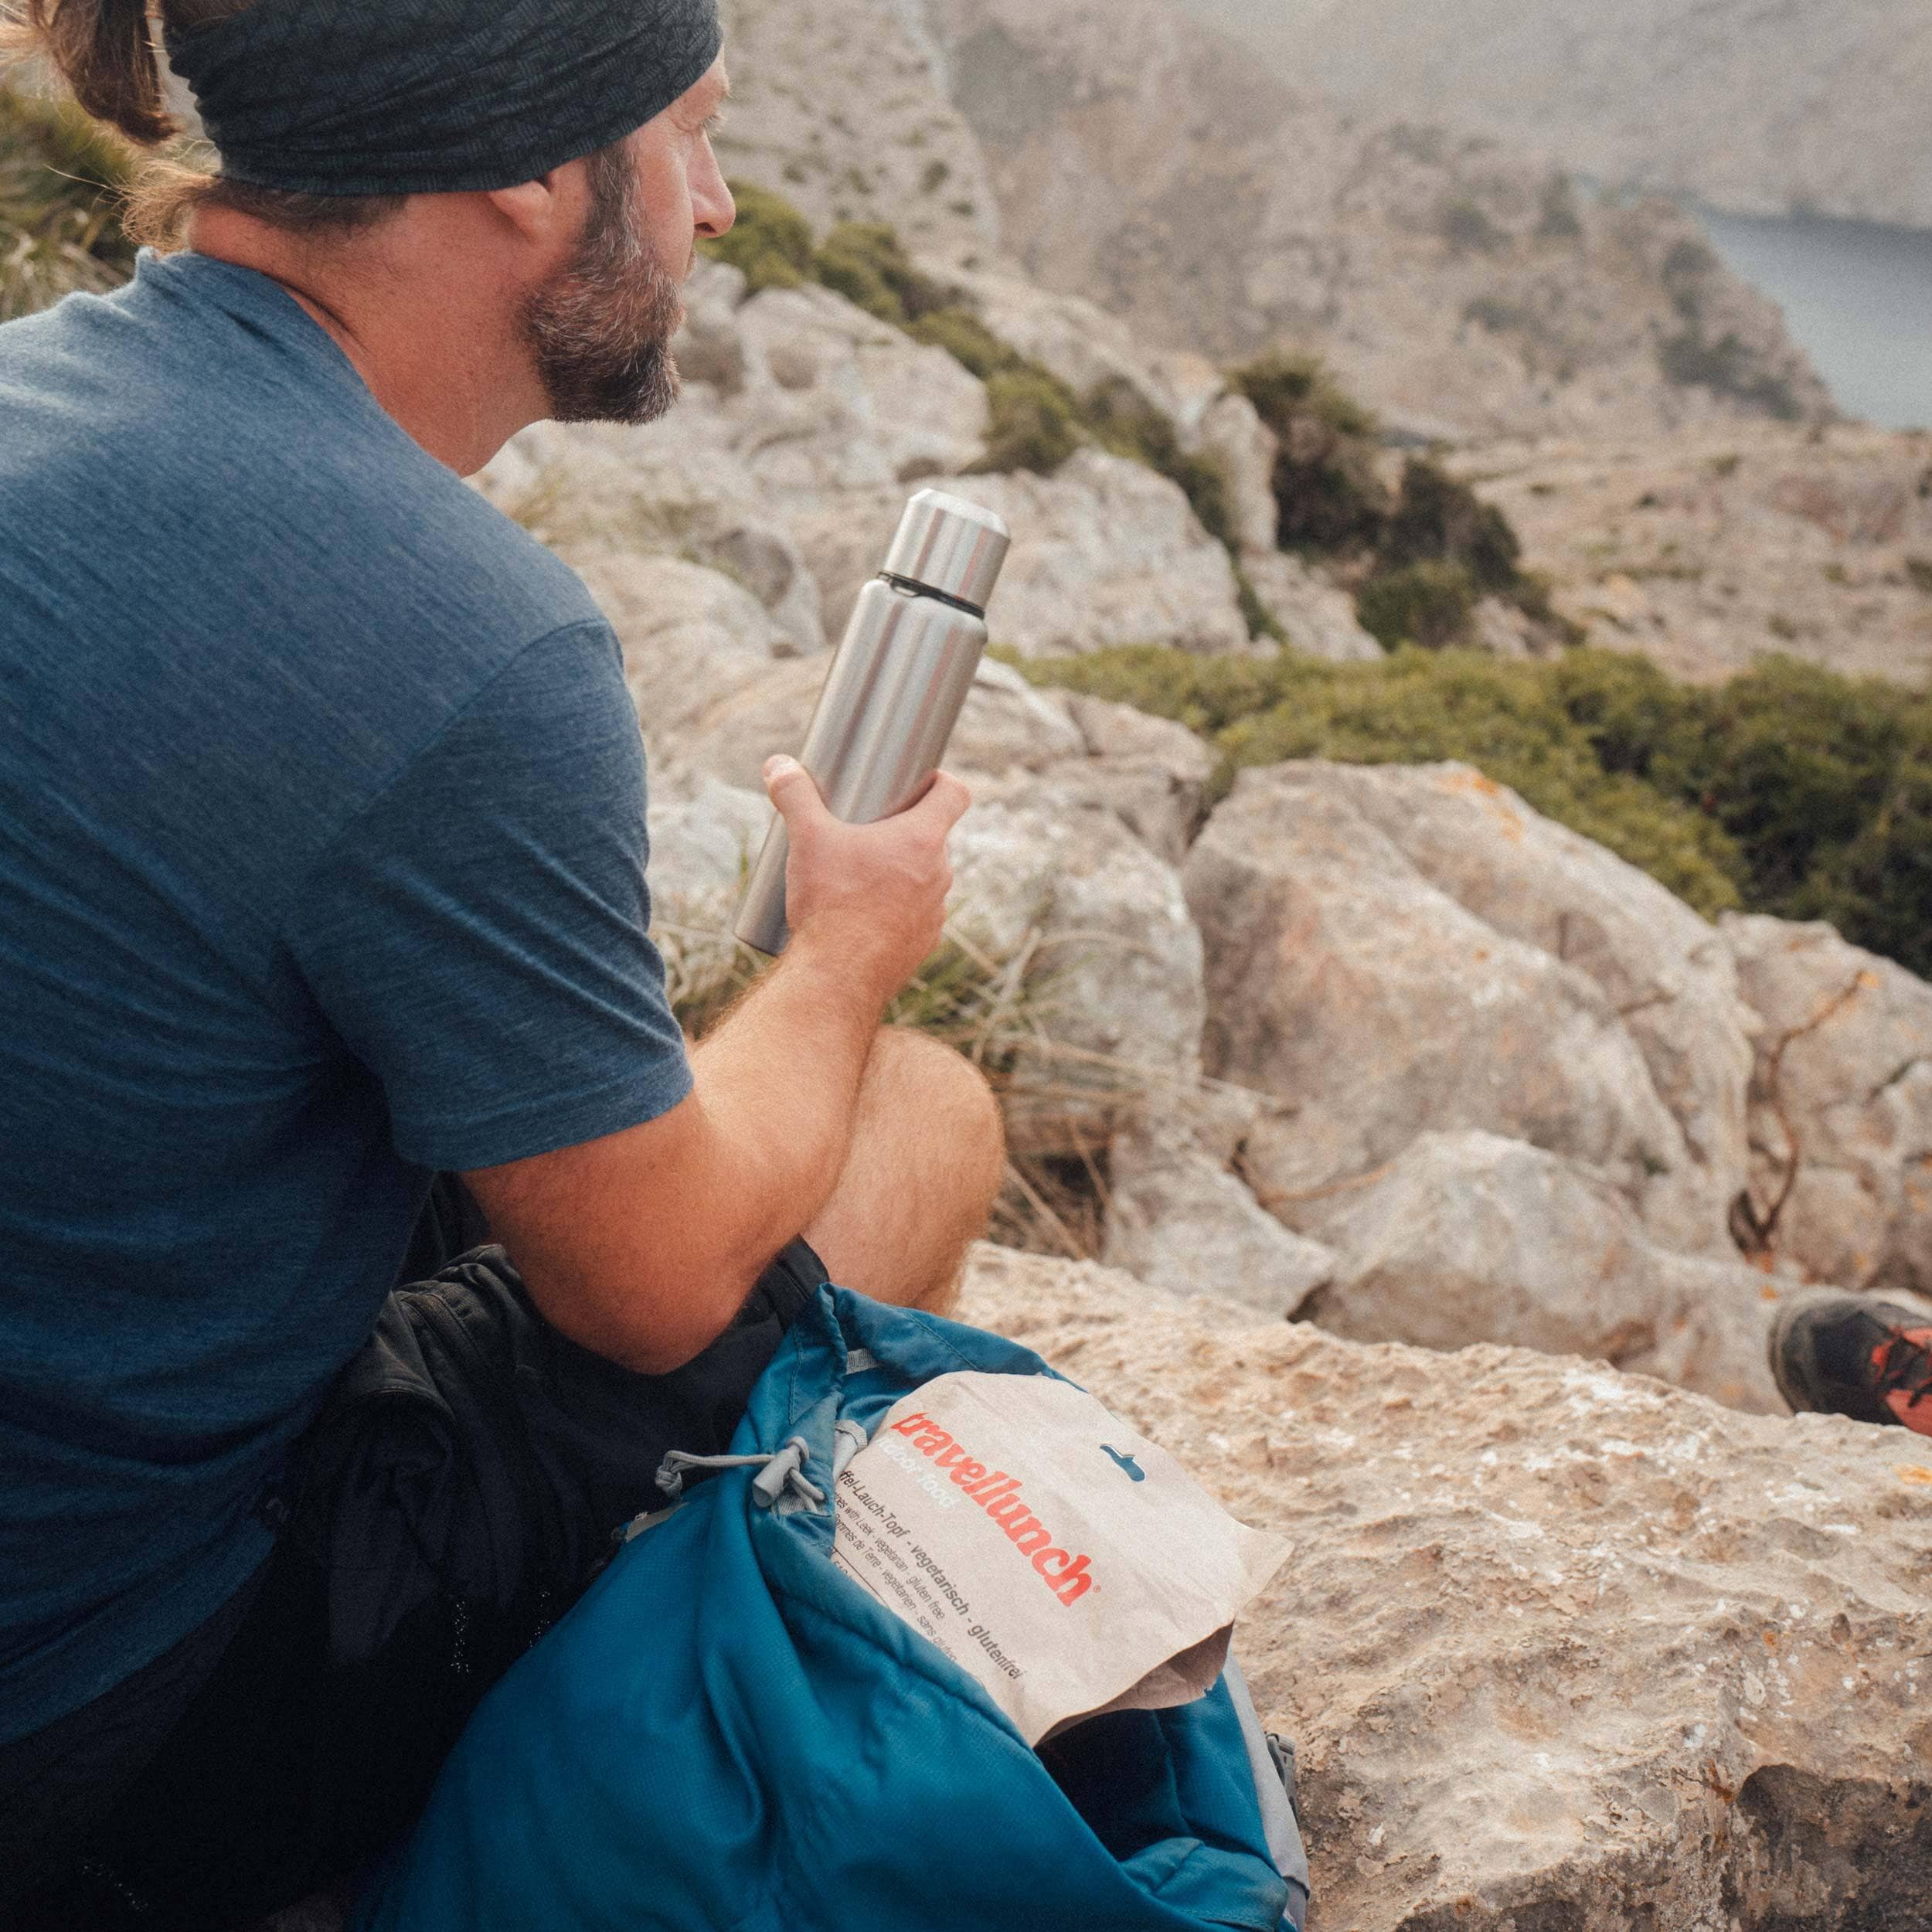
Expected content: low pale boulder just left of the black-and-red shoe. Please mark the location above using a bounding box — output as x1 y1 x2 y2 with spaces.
1302 1134 1785 1417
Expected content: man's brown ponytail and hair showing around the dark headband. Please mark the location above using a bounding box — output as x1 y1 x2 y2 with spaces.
10 0 406 247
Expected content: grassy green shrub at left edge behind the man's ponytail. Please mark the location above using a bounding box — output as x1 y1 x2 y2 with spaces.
0 85 135 323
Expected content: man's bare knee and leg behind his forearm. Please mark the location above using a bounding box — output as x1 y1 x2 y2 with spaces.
806 1026 1007 1314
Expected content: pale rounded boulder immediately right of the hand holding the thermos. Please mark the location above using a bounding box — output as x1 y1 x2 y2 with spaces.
951 779 1206 1154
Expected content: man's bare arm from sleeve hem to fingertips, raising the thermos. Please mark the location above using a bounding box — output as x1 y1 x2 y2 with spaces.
466 760 968 1374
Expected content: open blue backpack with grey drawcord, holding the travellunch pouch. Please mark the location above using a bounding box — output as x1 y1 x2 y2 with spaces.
352 1289 1308 1932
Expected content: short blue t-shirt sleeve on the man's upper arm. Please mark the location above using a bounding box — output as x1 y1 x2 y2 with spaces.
286 624 692 1171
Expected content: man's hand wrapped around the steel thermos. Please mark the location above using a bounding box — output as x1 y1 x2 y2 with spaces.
765 757 972 1007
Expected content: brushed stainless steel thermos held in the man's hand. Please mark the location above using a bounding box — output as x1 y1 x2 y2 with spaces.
736 489 1011 953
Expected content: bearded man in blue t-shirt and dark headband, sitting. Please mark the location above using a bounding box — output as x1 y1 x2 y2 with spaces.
0 0 1001 1932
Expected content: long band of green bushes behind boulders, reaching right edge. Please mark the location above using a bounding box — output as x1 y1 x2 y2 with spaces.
1020 648 1932 974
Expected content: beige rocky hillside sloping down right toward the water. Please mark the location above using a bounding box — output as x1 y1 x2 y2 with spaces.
729 0 1828 437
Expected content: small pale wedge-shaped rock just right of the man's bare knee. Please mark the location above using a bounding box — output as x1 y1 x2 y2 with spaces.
1104 1096 1339 1320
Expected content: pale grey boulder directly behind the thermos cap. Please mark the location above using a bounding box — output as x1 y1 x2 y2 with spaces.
792 451 1274 657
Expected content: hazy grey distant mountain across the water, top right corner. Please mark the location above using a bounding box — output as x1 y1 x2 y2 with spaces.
1185 0 1932 228
